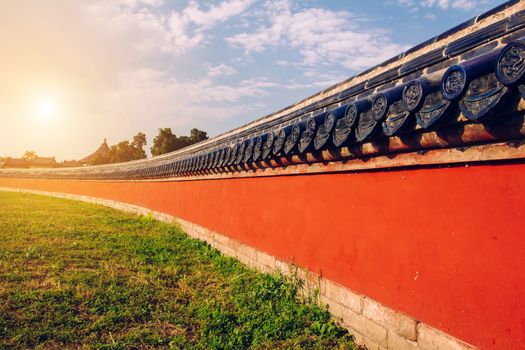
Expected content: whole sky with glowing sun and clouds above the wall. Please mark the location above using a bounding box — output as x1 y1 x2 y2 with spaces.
0 0 503 160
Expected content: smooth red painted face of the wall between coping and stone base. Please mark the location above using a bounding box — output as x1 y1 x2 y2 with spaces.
0 164 525 349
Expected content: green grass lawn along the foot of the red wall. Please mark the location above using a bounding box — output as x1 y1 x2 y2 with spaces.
0 192 357 349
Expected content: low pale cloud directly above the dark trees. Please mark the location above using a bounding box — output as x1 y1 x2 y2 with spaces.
103 69 275 136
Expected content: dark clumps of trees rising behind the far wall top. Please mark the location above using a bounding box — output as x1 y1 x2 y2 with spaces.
89 128 208 165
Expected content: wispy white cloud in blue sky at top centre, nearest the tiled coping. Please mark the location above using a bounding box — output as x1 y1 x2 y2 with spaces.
226 0 407 70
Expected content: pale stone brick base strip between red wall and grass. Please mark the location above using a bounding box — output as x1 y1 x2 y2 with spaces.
0 187 477 350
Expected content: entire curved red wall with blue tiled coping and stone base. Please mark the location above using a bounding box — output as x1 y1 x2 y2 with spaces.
0 0 525 350
